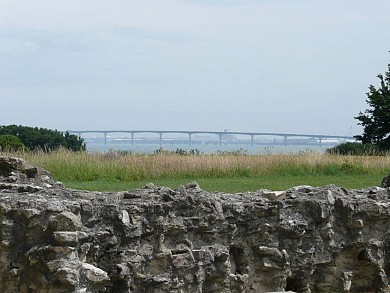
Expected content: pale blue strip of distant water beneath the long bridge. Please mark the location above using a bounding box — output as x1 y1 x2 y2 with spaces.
87 141 334 155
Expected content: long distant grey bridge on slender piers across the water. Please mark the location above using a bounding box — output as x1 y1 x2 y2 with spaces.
67 130 355 146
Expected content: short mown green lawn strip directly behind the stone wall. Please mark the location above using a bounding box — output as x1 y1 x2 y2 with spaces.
63 174 385 193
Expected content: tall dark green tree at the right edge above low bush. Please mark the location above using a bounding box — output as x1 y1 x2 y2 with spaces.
355 60 390 150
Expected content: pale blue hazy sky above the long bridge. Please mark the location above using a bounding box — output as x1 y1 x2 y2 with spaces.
0 0 390 135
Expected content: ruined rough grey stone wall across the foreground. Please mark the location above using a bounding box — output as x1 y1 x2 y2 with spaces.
0 157 390 293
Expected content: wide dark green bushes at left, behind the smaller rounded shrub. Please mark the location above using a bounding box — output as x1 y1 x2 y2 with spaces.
0 125 85 151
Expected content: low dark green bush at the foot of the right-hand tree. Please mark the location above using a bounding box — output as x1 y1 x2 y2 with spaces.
326 142 386 156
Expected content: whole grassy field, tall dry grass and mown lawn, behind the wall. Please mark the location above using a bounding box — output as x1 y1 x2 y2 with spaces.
2 150 390 193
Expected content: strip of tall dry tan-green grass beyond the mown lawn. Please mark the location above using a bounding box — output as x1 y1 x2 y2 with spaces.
0 149 390 181
